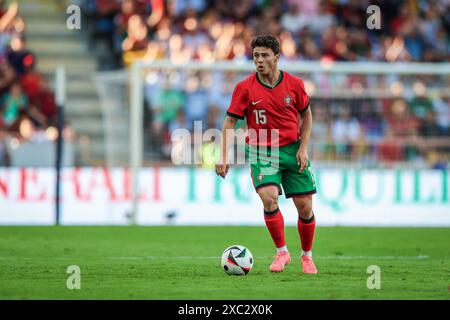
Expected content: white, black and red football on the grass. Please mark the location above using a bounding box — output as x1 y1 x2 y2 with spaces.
222 245 253 276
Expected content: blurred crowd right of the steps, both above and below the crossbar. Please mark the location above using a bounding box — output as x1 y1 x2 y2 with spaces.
81 0 450 168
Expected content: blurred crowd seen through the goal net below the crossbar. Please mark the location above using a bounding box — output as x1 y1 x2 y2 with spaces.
144 70 450 169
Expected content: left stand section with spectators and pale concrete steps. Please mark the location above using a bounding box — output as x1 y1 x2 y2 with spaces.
0 0 104 166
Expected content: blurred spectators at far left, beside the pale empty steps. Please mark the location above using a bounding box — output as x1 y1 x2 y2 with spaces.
0 0 61 166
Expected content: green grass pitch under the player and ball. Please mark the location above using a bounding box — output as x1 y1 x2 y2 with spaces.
0 227 450 299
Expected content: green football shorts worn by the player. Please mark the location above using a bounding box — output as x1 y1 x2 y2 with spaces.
245 141 317 198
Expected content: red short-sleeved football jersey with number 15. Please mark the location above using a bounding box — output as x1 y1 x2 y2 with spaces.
227 71 309 147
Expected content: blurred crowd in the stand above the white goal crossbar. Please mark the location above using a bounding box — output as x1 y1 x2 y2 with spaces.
84 0 450 68
